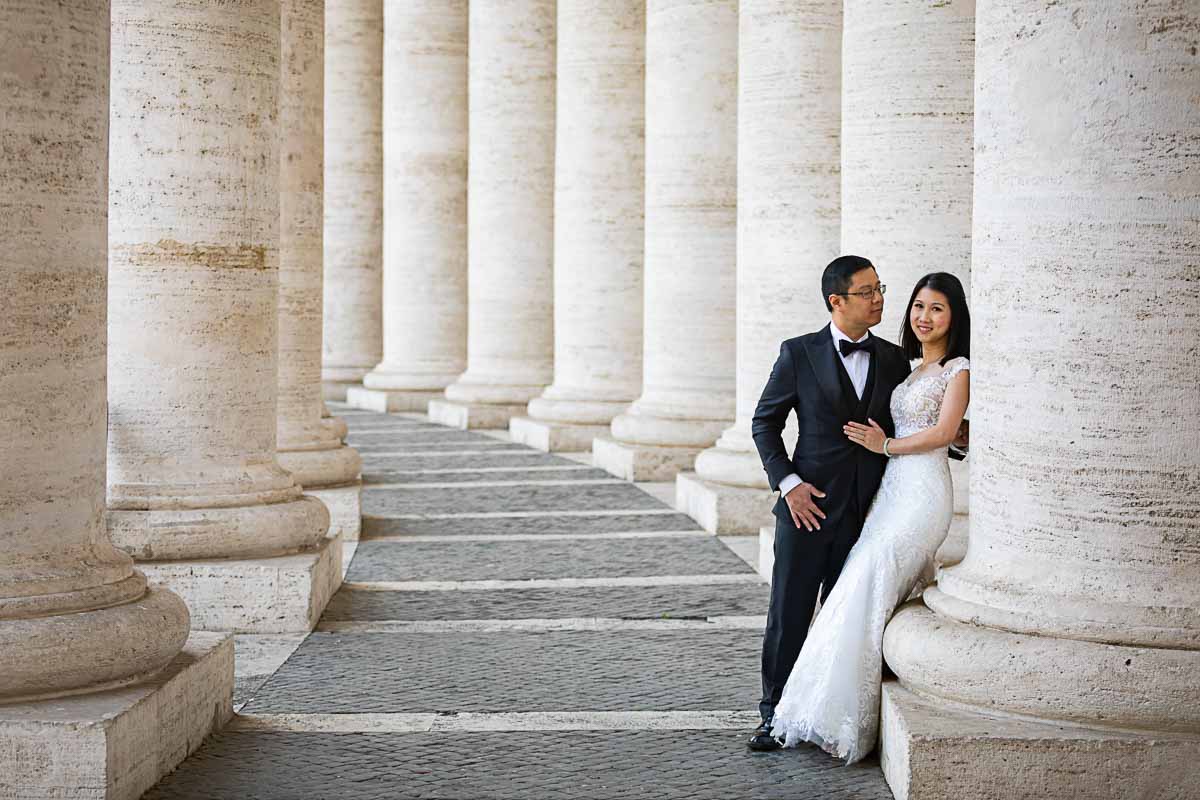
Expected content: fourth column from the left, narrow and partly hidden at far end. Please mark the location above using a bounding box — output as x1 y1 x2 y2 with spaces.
320 0 383 401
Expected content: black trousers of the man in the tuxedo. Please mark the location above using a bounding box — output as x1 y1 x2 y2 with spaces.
758 487 865 721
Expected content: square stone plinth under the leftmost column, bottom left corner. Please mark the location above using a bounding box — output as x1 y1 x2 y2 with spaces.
0 632 234 800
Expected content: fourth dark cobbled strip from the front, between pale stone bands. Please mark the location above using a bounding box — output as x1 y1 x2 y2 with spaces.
347 536 752 581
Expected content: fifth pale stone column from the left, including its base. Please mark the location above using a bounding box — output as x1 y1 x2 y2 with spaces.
347 0 467 411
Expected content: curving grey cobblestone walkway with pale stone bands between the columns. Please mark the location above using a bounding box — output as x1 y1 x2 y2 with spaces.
146 408 892 800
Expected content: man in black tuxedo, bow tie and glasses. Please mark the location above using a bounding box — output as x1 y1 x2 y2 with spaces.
748 255 910 751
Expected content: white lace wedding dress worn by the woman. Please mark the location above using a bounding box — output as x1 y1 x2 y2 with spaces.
772 357 970 764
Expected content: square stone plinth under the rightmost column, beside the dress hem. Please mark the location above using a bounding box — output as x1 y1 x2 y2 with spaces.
880 680 1200 800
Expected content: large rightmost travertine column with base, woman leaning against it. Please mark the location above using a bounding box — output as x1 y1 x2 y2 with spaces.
883 0 1200 800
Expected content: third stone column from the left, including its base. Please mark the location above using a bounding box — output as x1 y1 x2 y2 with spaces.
276 0 362 540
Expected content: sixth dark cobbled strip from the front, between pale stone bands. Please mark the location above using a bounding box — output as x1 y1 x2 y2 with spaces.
362 476 666 517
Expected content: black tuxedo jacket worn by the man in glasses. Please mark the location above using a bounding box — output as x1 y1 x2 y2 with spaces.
751 325 910 537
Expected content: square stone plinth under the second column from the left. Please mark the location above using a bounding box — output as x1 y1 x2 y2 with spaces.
138 536 342 633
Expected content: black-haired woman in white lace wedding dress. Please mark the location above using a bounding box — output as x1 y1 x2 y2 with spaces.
772 272 971 764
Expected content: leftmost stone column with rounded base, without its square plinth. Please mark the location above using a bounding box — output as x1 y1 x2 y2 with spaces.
0 0 188 702
